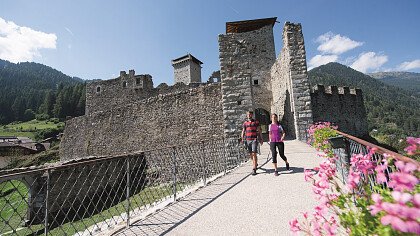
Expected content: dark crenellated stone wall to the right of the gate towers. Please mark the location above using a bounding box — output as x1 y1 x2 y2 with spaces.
311 85 368 137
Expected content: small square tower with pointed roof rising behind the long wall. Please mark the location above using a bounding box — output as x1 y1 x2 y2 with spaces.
172 53 203 85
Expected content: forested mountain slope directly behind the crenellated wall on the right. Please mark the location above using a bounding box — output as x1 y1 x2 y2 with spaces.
308 63 420 150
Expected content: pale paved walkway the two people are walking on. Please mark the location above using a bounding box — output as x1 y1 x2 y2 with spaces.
117 141 320 236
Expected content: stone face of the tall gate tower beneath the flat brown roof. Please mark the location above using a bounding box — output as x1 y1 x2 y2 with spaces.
219 25 275 138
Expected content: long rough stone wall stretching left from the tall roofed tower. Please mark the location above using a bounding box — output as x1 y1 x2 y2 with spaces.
60 83 223 160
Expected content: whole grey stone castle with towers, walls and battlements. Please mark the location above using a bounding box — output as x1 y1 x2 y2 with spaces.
60 18 368 160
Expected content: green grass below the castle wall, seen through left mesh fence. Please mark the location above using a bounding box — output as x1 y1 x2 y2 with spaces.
0 180 184 235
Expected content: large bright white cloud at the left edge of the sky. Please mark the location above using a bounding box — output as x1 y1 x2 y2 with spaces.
0 17 57 62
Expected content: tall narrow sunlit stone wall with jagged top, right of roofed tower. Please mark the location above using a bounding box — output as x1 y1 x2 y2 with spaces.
271 22 312 141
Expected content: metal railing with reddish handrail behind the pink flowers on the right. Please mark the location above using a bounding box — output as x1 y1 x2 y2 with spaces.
333 131 420 188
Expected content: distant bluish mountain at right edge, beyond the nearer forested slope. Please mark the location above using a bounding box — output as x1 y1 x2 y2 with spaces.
368 72 420 97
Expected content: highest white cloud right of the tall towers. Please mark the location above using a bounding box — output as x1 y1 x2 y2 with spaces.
316 32 363 55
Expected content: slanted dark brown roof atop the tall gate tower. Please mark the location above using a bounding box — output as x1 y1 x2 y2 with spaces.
226 17 277 33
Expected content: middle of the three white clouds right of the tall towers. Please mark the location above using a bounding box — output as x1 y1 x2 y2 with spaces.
350 52 388 73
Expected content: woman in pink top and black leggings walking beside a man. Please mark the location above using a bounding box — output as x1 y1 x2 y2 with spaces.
268 114 290 176
